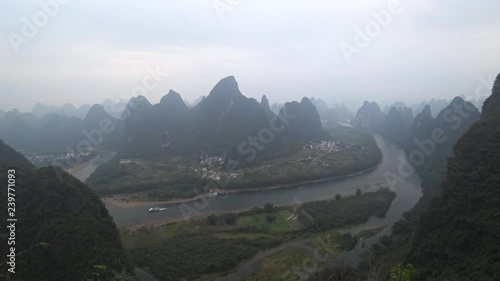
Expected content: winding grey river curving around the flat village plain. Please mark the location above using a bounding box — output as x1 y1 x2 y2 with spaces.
75 135 422 232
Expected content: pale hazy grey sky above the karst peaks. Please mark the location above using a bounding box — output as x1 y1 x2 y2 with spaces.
0 0 500 111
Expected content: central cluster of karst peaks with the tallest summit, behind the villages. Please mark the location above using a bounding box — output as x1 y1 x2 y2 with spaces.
121 76 324 159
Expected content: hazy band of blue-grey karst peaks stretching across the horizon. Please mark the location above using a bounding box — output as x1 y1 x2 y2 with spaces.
0 76 480 156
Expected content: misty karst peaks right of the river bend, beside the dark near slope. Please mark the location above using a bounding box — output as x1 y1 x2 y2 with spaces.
352 97 481 203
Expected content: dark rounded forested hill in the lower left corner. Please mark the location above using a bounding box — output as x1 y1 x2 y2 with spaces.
0 140 132 281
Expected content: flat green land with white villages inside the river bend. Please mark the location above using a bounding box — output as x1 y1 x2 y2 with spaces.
87 128 381 201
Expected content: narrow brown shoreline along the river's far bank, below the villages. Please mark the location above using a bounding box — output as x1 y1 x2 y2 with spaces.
101 155 384 209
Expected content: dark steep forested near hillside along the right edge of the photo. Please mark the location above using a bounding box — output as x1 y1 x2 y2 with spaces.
410 75 500 281
